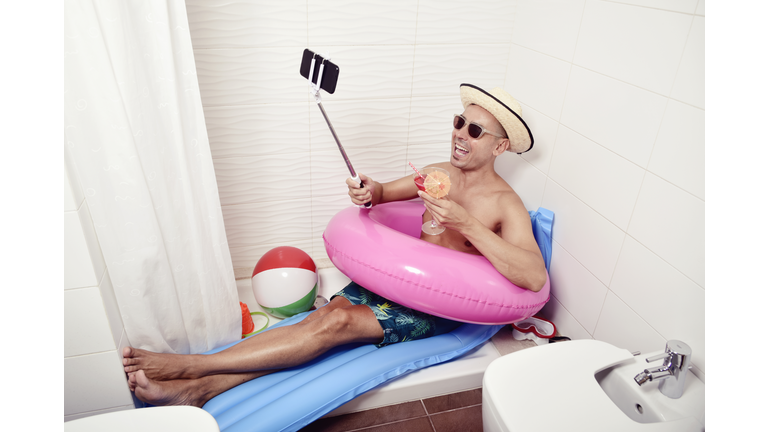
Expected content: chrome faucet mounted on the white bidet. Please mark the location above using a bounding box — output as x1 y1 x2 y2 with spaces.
635 340 691 399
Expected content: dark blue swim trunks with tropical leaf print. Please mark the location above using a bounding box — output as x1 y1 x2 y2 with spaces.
331 282 463 348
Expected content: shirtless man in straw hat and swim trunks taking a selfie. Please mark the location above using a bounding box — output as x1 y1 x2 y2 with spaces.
123 84 547 407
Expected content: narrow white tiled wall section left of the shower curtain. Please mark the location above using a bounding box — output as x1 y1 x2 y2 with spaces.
63 156 135 421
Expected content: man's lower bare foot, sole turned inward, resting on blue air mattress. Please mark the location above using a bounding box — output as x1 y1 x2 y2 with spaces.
128 370 205 408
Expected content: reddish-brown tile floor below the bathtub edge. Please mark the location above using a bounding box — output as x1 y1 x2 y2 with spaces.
302 389 483 432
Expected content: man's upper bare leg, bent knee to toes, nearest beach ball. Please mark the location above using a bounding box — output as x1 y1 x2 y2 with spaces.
123 297 384 380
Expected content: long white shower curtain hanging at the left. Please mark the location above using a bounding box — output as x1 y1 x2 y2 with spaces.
64 0 241 354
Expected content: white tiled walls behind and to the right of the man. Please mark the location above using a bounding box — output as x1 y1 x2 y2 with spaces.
187 0 705 376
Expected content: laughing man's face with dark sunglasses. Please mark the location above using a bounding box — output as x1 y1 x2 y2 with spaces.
451 105 506 168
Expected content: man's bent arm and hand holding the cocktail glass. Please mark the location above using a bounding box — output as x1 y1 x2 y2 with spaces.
419 193 547 292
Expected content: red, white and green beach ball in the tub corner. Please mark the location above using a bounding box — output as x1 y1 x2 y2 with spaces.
251 246 317 318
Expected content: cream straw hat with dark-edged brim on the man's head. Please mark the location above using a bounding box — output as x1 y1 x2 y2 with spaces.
459 84 533 154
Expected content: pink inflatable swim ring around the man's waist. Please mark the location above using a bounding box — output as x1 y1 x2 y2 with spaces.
323 201 549 324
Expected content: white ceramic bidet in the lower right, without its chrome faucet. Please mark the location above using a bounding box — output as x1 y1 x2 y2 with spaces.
483 340 705 432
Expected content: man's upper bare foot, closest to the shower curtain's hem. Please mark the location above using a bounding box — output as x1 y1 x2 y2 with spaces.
123 347 200 381
